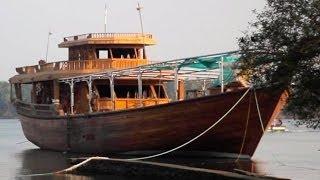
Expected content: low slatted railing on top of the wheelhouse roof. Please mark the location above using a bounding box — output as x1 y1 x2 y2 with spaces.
64 33 152 42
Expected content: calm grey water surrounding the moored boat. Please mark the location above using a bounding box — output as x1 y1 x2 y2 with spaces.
0 119 320 180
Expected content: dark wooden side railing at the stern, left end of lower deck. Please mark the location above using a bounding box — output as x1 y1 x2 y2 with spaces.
15 100 58 117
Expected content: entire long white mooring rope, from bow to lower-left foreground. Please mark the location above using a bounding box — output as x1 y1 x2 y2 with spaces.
18 87 251 177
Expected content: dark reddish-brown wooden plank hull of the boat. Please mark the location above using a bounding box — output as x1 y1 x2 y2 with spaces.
20 89 286 156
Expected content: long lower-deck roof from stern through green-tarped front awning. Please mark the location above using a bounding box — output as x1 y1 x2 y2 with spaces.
9 51 239 85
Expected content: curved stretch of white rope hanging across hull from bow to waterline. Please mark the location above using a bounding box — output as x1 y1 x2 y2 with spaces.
126 88 251 161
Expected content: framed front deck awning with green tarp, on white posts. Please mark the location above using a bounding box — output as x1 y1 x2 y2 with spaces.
60 51 239 84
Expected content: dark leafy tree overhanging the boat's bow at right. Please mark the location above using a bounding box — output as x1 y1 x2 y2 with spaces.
238 0 320 128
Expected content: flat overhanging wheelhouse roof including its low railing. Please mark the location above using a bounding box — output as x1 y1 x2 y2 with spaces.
59 33 156 48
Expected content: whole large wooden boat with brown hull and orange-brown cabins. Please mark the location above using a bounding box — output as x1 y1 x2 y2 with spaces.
9 33 286 157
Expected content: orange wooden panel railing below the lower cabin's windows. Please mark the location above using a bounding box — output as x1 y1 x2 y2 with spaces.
97 98 170 111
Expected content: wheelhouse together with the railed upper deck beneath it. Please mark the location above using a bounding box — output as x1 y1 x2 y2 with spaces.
10 33 156 83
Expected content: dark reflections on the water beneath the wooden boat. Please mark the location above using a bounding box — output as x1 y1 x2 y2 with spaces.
15 149 259 180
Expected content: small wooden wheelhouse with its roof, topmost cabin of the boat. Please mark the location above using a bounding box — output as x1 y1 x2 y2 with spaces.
59 33 155 62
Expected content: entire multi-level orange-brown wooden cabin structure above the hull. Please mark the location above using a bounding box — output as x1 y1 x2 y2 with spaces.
9 33 175 116
